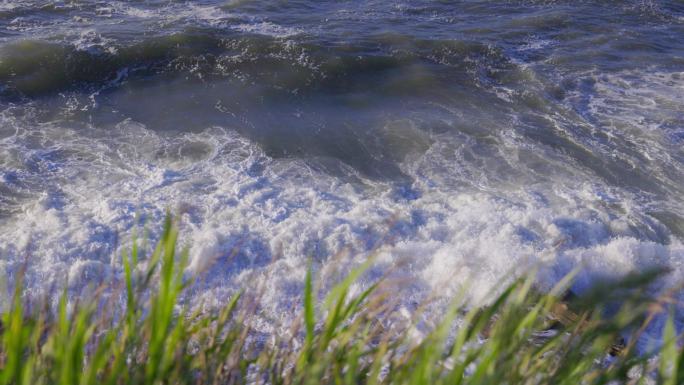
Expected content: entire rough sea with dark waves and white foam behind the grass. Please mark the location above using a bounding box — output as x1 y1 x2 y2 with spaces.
0 0 684 342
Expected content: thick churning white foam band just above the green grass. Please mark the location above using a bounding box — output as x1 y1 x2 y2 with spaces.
0 106 684 342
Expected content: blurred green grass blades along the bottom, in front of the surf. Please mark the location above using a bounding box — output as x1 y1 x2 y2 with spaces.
0 218 684 385
